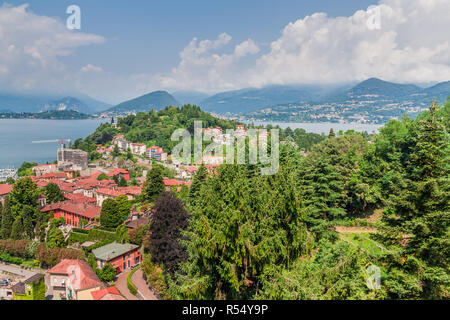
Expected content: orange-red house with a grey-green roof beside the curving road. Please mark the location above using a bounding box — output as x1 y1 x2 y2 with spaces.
92 242 142 274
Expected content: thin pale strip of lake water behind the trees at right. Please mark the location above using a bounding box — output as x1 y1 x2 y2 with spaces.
246 121 383 135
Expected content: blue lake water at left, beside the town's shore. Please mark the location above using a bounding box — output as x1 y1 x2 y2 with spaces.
0 119 109 168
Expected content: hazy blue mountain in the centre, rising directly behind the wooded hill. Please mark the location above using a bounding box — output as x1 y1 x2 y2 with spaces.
200 86 315 114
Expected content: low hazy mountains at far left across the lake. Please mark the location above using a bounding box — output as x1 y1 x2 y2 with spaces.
0 93 111 114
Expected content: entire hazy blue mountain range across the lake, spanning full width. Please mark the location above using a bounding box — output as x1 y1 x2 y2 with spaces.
0 78 450 119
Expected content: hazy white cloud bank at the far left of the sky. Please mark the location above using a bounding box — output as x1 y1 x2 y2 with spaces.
0 4 105 91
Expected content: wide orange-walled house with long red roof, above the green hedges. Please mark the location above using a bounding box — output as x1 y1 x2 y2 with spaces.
41 200 102 228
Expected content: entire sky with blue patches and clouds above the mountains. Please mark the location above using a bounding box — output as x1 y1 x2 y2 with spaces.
0 0 450 104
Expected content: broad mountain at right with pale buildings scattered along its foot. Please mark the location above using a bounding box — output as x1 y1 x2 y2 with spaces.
241 78 450 123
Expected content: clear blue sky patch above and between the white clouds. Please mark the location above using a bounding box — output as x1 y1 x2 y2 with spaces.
6 0 374 74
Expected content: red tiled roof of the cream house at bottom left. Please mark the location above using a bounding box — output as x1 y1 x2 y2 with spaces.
48 260 103 291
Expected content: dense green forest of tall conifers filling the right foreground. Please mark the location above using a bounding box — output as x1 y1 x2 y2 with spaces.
144 101 450 300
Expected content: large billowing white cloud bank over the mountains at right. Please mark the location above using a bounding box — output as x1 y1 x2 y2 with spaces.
145 0 450 91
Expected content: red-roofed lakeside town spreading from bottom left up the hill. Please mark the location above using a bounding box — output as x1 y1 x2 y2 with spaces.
0 125 253 300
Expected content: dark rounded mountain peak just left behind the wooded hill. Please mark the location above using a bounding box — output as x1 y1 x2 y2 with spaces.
107 91 180 112
